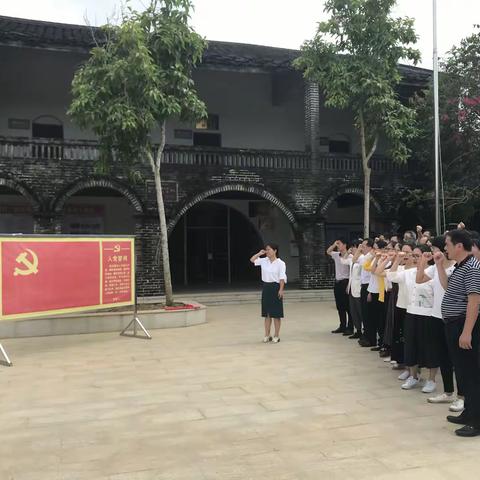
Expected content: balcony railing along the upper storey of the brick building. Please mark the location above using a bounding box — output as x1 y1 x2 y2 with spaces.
0 138 405 173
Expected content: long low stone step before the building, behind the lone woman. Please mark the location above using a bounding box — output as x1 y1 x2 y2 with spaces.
139 289 334 306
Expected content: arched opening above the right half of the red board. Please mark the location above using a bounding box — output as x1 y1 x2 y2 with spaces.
61 187 136 235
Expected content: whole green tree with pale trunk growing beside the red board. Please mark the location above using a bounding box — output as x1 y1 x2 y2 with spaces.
69 0 206 305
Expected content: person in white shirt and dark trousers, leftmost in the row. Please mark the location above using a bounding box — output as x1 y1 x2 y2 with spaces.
327 238 353 335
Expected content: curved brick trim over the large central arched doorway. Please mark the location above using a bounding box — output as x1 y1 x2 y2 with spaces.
168 183 298 233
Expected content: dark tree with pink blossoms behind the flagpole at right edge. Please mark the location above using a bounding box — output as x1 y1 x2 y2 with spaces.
406 27 480 229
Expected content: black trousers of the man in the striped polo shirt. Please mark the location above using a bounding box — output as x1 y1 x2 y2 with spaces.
445 318 480 428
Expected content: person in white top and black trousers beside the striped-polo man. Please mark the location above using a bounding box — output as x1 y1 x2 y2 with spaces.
417 236 464 412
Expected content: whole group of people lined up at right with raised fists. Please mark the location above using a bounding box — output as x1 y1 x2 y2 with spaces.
327 224 480 437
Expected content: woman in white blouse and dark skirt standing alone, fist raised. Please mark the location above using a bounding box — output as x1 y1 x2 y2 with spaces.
250 243 287 343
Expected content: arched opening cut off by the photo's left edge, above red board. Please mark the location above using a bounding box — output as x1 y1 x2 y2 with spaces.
0 185 34 234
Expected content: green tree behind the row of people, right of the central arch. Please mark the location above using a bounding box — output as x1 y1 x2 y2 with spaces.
295 0 420 236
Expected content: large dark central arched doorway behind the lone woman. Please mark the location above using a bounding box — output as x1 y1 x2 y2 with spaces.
169 191 299 288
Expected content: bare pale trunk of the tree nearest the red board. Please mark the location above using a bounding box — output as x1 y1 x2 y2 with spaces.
148 122 173 306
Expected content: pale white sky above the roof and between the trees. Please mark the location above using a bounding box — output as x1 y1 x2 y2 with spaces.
0 0 480 68
